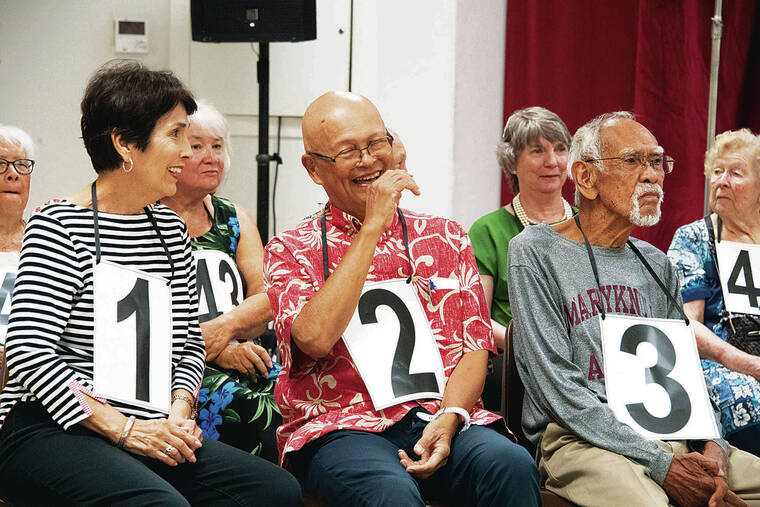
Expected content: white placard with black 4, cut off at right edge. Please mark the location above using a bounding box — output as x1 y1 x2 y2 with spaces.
715 241 760 315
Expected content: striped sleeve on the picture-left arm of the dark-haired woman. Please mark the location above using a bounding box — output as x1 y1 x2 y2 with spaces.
6 210 92 429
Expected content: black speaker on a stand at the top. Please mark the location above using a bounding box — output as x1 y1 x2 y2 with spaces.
190 0 317 42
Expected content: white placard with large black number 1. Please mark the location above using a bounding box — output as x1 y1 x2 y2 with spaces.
93 261 172 413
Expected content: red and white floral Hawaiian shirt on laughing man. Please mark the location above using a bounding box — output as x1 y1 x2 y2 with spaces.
264 204 500 461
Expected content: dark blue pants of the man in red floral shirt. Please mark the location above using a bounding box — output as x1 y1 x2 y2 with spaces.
290 409 541 507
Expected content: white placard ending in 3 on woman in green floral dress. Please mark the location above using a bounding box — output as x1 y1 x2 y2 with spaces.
193 250 245 322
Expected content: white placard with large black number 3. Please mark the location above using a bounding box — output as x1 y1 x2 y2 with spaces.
600 315 719 440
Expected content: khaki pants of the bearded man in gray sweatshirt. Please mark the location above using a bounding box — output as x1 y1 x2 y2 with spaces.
538 423 760 507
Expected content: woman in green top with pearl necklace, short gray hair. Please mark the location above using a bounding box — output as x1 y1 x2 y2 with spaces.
469 107 573 410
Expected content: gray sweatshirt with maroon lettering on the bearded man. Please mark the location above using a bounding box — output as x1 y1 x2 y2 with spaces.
509 225 681 484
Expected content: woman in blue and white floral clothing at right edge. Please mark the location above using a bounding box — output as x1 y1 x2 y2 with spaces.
668 129 760 456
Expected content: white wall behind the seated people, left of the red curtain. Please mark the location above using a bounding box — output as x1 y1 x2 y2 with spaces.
0 0 506 232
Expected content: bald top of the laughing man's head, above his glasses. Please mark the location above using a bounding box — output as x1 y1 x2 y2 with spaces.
301 91 383 156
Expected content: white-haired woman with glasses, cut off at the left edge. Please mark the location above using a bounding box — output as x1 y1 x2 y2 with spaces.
0 125 34 391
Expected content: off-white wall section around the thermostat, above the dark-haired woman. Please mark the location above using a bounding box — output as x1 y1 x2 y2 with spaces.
0 0 174 216
